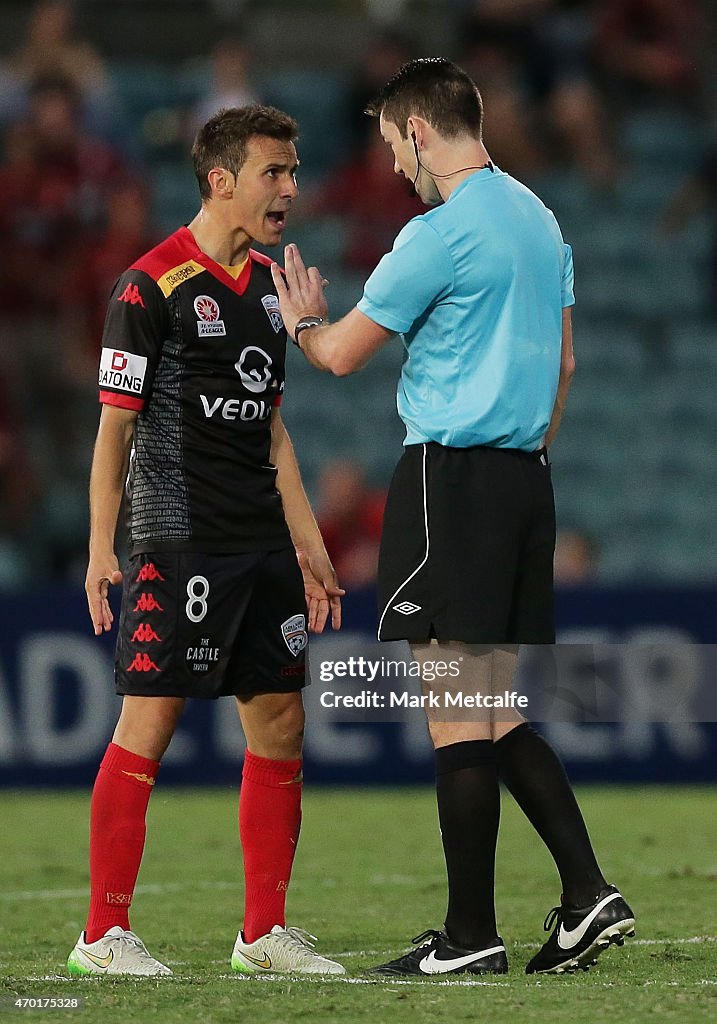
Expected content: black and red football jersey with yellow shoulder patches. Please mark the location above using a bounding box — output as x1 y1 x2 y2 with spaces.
99 227 291 554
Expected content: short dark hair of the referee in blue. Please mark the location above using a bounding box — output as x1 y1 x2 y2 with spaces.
366 57 483 138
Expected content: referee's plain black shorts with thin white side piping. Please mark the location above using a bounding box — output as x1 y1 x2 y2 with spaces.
378 442 555 644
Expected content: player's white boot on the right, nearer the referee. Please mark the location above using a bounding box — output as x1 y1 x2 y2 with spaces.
231 925 346 974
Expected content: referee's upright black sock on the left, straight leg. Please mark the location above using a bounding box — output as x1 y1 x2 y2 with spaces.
435 739 500 949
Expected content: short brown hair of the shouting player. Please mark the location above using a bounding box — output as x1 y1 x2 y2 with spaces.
192 103 299 199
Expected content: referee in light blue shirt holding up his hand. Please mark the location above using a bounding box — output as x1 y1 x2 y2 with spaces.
272 58 635 976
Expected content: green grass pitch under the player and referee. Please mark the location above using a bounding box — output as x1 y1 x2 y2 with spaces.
0 784 717 1024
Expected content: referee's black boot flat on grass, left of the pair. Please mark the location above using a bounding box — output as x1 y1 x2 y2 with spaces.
369 930 508 978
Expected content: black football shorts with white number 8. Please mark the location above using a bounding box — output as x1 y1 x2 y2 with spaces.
115 548 307 697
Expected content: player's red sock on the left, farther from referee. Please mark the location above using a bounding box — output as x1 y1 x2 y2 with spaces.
85 743 160 942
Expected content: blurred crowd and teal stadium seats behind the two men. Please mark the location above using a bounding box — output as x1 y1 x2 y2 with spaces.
0 0 717 590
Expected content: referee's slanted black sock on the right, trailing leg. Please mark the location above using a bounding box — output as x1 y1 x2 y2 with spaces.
494 722 606 906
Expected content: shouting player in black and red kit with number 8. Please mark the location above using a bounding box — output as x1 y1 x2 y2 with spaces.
68 105 344 975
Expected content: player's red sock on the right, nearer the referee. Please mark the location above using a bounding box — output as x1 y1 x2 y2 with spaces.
239 751 301 942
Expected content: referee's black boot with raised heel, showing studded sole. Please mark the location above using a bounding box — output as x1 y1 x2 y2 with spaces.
525 886 635 974
